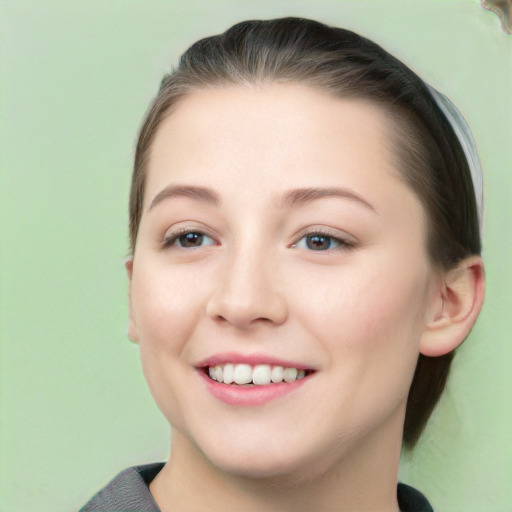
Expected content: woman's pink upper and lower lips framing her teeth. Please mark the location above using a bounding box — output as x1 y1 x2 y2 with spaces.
196 352 315 407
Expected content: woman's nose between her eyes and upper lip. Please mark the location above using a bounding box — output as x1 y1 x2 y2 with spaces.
207 248 288 330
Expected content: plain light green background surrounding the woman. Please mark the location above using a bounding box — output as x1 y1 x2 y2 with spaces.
0 0 512 512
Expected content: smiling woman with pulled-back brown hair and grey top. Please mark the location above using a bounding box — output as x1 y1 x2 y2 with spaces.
82 18 484 512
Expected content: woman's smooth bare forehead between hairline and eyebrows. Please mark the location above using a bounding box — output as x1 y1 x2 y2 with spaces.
146 84 424 223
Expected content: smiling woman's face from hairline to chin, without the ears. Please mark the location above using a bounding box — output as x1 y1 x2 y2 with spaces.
130 84 436 476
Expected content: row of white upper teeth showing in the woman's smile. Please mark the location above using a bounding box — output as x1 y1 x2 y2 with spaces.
208 363 306 386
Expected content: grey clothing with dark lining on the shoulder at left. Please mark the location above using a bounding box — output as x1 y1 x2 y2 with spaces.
80 463 164 512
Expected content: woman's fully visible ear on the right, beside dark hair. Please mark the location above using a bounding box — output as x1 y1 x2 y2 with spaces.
420 256 485 357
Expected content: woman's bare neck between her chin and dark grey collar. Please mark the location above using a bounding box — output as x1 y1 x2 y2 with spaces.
150 416 401 512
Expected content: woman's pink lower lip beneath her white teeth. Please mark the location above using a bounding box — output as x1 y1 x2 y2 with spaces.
199 370 311 407
